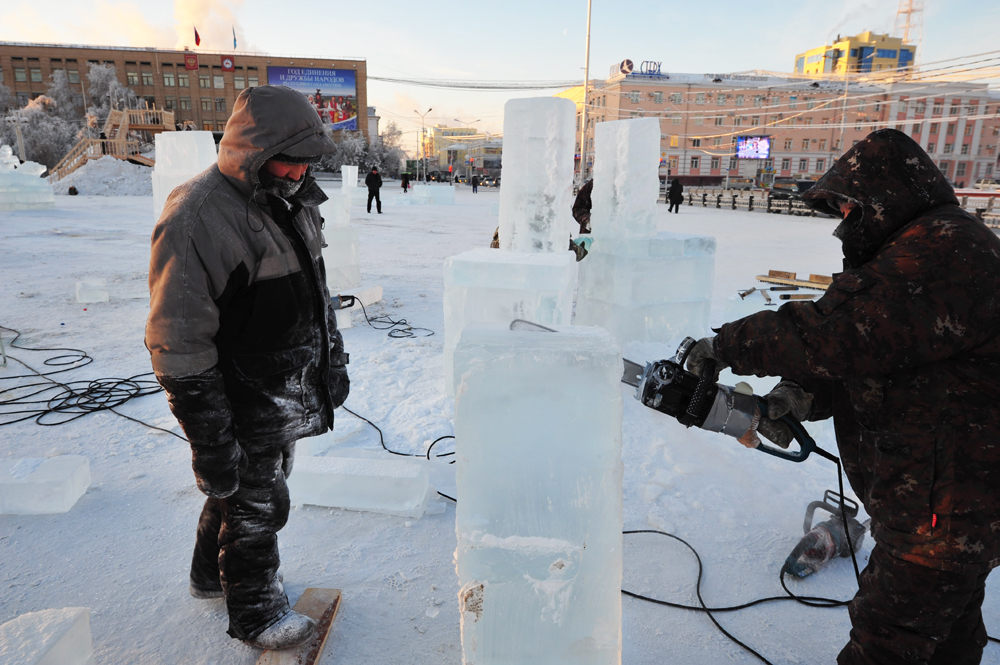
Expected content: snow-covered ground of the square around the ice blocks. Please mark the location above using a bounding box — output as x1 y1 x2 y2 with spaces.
0 187 1000 665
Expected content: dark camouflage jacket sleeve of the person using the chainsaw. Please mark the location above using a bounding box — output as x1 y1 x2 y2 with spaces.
715 224 997 384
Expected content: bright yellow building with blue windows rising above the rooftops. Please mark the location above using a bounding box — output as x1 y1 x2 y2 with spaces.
794 30 917 75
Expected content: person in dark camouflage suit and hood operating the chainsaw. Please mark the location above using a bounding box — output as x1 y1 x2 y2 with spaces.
689 129 1000 665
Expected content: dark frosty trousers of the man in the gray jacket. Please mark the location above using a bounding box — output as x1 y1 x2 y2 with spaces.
191 443 295 639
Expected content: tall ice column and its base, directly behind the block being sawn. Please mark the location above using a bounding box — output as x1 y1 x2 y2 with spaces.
444 97 576 395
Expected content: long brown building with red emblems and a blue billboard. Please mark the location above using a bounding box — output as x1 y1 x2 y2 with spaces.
0 42 368 137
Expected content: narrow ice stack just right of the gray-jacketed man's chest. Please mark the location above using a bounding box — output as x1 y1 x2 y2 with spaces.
319 166 361 294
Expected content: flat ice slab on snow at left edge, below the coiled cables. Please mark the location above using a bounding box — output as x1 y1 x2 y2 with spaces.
0 455 90 515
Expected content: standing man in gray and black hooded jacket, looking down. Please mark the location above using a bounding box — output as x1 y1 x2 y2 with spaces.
146 86 349 649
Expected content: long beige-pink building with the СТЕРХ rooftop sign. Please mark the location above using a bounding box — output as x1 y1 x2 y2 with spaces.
560 61 1000 186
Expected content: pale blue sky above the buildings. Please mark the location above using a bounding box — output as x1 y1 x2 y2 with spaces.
0 0 1000 150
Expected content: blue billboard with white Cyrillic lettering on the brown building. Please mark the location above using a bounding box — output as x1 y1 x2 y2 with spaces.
267 67 358 131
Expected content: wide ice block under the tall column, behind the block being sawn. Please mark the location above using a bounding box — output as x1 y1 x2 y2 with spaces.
444 249 576 395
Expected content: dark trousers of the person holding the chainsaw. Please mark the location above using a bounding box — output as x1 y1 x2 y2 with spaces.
837 545 989 665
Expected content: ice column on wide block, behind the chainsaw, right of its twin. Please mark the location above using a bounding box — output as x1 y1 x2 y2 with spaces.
575 118 715 343
